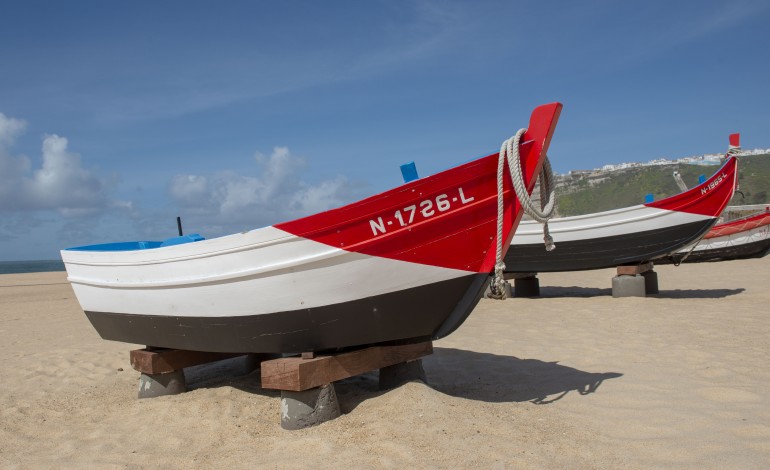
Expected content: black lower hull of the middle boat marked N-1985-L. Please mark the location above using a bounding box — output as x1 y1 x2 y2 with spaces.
505 219 716 273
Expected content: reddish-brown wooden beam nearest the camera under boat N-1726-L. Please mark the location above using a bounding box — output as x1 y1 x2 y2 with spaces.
262 341 433 392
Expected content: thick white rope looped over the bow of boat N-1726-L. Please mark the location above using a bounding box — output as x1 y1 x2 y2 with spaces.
490 129 556 299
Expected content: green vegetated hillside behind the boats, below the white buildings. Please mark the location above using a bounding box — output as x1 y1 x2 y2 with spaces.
556 154 770 217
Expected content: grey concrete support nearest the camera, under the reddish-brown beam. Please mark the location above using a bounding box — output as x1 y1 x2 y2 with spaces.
281 384 340 430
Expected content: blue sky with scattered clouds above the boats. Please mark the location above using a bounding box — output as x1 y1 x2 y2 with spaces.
0 0 770 260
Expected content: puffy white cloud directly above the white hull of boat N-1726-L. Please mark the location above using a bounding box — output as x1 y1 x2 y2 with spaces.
168 147 352 227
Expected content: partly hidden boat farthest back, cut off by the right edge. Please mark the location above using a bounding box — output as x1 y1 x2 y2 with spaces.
656 207 770 264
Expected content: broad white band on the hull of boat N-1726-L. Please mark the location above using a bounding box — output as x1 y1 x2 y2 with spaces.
67 229 473 316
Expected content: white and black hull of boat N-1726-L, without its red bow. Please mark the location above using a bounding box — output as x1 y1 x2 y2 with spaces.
66 227 492 353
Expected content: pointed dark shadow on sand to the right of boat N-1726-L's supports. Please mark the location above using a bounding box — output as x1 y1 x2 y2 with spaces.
416 348 623 405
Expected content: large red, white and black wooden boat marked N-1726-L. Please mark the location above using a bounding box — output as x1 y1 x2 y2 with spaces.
61 103 562 353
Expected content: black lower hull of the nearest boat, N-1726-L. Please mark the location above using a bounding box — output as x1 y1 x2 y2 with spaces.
86 274 489 353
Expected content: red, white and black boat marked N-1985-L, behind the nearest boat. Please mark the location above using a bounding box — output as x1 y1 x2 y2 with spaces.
505 157 737 273
